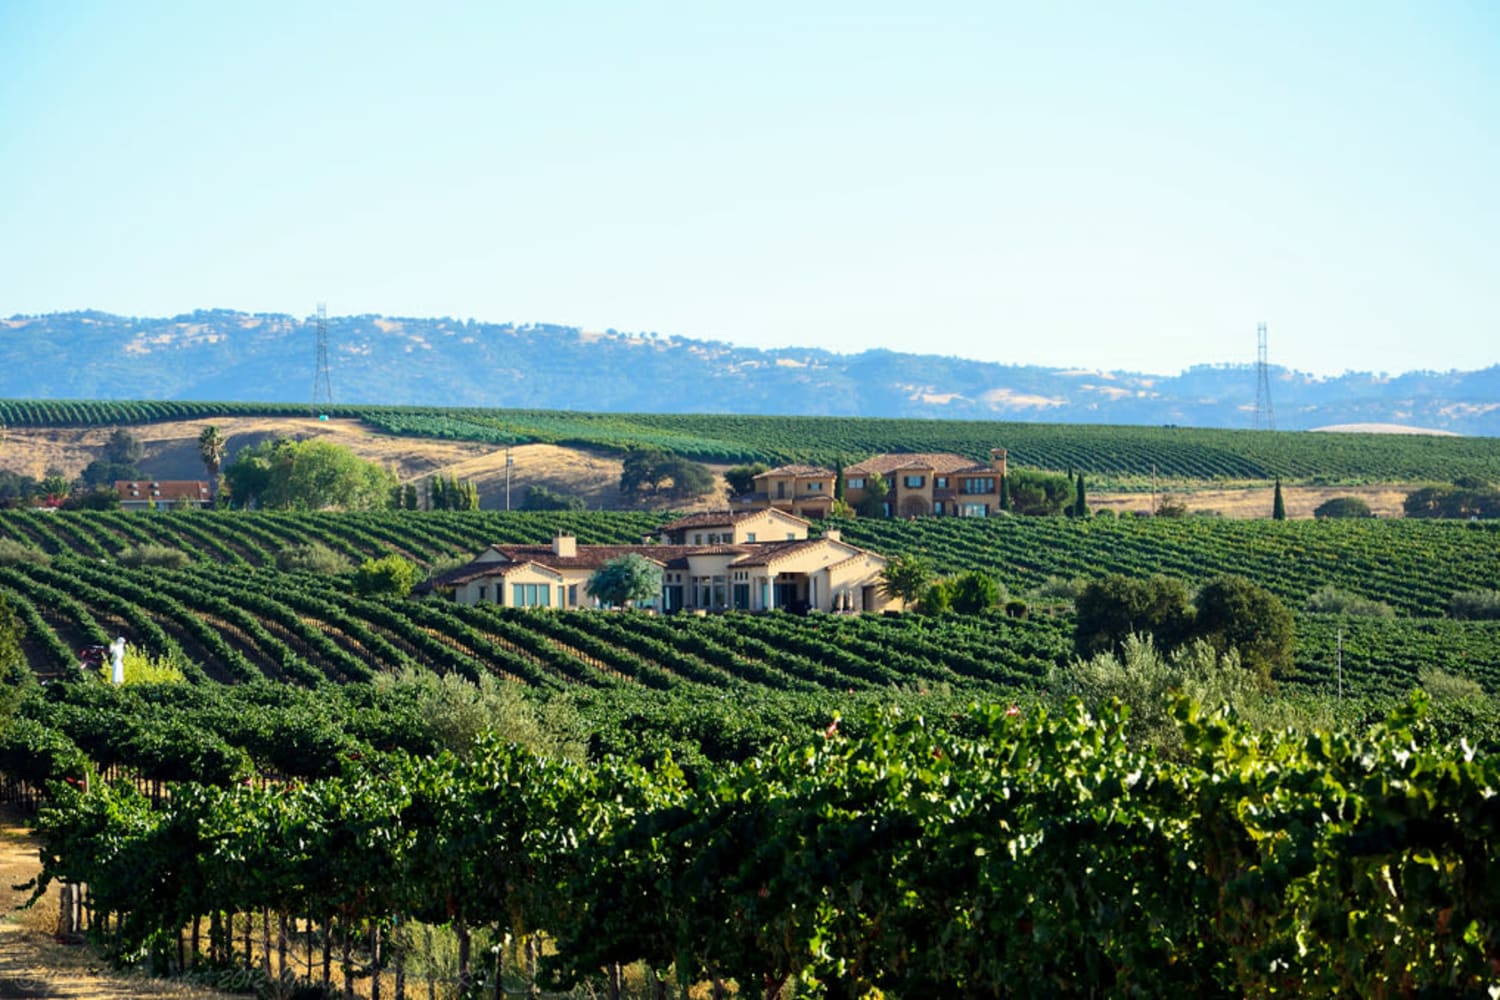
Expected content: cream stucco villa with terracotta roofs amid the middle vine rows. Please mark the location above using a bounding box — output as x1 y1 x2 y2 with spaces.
434 508 900 612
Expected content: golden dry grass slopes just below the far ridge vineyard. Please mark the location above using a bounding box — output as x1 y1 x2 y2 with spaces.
0 417 1412 519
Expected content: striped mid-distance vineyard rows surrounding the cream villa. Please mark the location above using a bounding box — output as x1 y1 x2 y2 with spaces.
0 511 1500 694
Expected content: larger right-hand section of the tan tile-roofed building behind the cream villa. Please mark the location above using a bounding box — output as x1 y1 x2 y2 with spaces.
845 448 1007 517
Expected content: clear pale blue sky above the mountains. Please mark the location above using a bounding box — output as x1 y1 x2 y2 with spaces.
0 0 1500 375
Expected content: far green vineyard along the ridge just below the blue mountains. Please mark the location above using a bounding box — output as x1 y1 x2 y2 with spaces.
0 400 1500 484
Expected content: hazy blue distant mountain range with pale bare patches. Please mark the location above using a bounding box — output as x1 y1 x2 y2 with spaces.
0 309 1500 436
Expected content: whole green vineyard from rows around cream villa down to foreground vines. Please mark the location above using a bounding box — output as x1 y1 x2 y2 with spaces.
0 510 1500 1000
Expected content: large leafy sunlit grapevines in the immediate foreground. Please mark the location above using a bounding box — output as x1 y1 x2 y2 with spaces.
17 703 1500 1000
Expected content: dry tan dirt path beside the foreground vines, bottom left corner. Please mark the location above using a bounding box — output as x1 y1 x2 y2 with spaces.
0 808 228 1000
